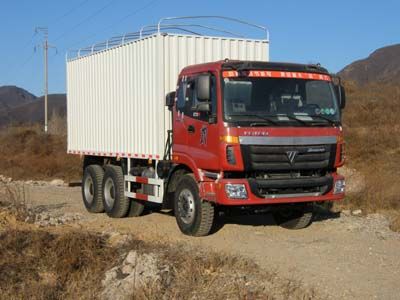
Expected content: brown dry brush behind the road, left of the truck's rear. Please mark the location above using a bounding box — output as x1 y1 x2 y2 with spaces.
0 126 81 180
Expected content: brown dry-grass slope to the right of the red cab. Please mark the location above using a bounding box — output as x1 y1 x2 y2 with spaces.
344 83 400 226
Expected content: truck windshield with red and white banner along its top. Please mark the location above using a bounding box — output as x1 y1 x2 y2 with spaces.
223 72 340 126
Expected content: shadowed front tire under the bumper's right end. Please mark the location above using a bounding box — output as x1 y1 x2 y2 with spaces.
272 203 314 229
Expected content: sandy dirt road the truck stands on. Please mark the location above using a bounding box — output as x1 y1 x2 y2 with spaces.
18 185 400 299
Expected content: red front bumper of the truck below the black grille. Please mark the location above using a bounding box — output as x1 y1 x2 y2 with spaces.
200 173 344 206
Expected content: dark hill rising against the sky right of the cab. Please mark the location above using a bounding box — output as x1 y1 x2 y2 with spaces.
339 44 400 85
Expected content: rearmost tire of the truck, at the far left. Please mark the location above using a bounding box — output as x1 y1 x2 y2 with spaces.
82 165 104 213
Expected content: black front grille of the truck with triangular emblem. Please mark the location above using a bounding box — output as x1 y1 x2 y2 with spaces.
241 144 336 197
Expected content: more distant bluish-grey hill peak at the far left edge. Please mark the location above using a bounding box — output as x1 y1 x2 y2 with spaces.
0 85 36 112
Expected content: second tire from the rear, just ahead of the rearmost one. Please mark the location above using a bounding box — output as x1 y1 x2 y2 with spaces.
102 165 130 218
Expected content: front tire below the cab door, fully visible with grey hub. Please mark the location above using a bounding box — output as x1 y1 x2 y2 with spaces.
174 174 214 236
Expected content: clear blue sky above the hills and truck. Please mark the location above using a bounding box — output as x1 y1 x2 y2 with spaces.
0 0 400 95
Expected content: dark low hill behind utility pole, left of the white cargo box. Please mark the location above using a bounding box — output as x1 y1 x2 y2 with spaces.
0 94 66 127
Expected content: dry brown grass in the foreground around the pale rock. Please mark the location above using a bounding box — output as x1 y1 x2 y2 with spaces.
0 185 318 300
